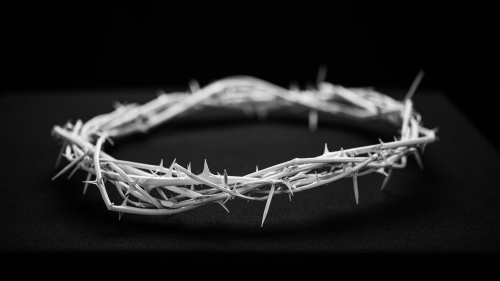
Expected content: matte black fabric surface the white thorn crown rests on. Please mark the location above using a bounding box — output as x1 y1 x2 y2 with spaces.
0 89 500 276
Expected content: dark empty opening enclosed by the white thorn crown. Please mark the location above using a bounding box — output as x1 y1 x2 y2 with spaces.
104 106 399 176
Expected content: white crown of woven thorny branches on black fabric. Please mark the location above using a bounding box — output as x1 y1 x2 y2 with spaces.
52 71 436 226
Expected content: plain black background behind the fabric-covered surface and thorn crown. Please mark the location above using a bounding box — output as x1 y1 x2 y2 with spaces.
2 1 499 151
